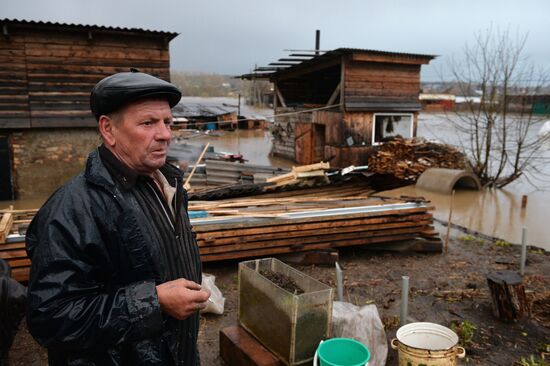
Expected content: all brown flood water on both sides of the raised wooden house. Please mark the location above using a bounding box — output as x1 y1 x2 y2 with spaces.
0 114 550 250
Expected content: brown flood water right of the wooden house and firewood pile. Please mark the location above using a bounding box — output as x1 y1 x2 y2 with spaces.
381 114 550 250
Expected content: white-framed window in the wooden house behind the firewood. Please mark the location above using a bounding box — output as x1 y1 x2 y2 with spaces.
372 113 414 145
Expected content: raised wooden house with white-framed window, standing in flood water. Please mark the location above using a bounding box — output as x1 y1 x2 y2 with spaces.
241 48 435 167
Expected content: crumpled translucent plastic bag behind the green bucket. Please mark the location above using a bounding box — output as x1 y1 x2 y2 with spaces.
332 301 388 366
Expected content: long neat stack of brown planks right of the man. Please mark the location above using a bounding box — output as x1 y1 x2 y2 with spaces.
193 197 440 262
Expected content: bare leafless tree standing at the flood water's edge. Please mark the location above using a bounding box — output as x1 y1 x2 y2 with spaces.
450 28 549 188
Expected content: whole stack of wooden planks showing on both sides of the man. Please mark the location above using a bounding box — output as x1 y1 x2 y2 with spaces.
0 182 441 281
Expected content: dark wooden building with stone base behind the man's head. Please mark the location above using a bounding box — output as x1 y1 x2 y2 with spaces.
0 19 177 200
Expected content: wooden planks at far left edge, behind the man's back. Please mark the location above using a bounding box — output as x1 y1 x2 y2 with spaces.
0 209 38 281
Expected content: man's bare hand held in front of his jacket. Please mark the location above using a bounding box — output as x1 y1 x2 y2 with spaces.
157 278 210 320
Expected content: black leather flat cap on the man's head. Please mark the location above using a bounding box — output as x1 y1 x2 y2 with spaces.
90 71 181 120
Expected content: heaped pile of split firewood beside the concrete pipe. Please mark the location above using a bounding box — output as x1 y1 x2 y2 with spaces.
368 138 466 181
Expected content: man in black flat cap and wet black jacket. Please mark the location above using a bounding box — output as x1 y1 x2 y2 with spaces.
23 72 210 365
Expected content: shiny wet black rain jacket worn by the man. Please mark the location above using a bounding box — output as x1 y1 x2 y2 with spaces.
26 150 200 365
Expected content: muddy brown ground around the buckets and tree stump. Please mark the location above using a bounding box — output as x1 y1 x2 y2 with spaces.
6 225 550 366
